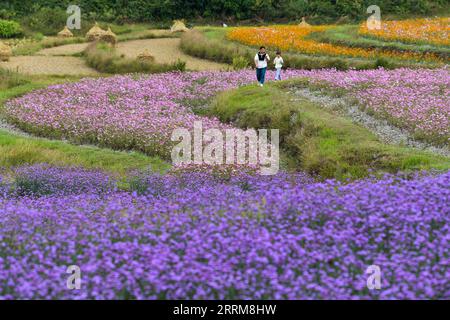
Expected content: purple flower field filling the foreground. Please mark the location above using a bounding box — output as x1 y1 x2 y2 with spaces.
0 166 450 299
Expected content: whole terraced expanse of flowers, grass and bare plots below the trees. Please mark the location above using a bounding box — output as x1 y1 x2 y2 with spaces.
0 15 450 300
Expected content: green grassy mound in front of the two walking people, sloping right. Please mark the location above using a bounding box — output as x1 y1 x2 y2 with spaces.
207 82 450 179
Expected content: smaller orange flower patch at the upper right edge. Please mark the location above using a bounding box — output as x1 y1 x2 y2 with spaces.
359 17 450 46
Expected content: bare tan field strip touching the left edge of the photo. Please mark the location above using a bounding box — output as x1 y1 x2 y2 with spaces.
0 56 98 76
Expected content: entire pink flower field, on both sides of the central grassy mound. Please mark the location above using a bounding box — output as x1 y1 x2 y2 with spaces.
6 68 450 157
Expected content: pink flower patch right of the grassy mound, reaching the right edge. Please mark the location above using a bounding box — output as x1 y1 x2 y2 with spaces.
311 68 450 145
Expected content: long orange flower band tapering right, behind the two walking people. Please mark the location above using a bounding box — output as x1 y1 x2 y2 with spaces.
227 25 440 61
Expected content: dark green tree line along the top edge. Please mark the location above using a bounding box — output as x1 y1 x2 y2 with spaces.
0 0 448 23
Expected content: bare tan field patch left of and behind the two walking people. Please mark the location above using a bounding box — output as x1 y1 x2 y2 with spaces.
117 38 229 71
